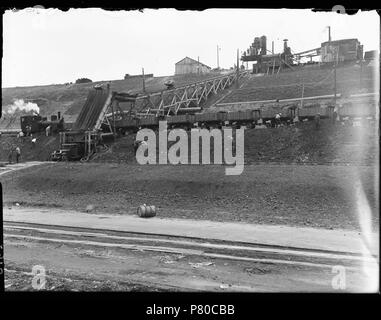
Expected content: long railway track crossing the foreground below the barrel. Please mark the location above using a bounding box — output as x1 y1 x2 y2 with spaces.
3 221 378 270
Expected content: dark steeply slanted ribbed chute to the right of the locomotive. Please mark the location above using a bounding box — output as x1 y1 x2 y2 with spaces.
73 88 109 130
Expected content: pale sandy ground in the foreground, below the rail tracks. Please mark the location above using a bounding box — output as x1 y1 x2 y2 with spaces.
4 222 370 292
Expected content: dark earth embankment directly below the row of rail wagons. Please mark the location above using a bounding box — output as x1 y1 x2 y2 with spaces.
0 120 379 165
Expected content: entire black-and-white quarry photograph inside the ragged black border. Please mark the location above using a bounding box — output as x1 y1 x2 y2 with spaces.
0 5 380 296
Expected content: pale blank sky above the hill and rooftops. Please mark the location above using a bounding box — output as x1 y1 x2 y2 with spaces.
2 9 380 87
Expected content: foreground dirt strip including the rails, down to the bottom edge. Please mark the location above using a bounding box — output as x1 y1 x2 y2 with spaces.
4 222 375 292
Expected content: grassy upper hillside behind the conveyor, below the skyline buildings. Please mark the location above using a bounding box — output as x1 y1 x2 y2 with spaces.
0 65 377 130
